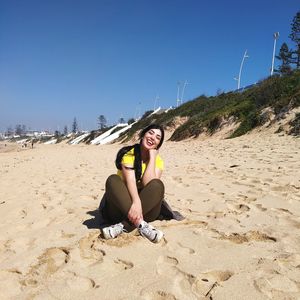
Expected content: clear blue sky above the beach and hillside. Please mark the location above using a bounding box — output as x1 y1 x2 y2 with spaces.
0 0 300 131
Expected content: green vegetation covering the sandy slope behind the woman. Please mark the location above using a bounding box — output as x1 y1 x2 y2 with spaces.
123 70 300 141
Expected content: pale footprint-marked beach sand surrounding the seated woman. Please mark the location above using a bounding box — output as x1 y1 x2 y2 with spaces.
0 133 300 300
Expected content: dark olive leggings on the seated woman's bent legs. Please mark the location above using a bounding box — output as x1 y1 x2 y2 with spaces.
105 175 165 223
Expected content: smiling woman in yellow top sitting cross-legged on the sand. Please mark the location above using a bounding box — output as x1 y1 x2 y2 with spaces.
102 124 164 243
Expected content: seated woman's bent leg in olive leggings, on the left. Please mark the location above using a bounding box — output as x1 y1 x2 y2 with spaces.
105 175 132 223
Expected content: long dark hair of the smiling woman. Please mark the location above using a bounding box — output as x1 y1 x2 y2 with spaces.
115 124 165 181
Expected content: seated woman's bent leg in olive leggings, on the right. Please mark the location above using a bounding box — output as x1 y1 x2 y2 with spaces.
139 179 165 222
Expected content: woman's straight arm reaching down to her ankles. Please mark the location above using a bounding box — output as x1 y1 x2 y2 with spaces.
122 165 143 225
